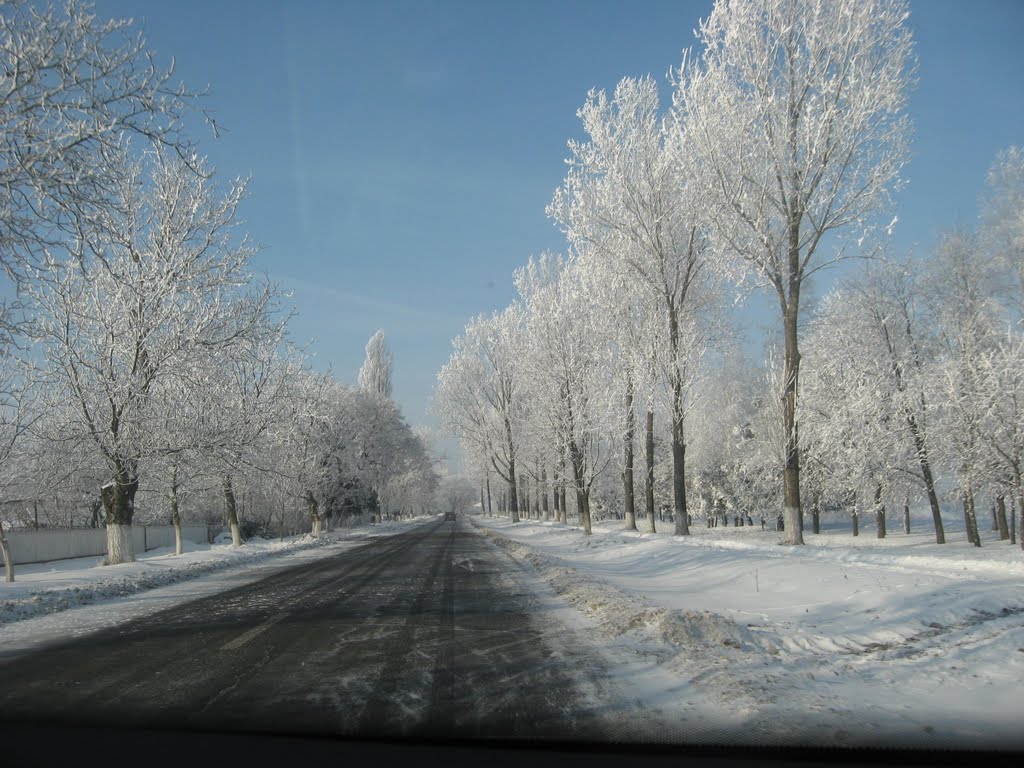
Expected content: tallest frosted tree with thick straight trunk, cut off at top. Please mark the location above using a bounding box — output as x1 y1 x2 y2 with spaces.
674 0 913 544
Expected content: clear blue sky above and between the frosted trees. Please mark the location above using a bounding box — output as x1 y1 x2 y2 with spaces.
95 0 1024 424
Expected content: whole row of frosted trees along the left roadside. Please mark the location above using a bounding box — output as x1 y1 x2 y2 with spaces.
0 0 436 572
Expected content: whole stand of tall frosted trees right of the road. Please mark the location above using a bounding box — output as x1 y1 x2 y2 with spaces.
436 0 1024 544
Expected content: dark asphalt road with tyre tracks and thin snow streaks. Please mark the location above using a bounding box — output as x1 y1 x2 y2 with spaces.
0 519 622 741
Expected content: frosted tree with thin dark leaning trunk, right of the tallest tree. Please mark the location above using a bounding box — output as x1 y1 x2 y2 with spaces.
801 262 945 544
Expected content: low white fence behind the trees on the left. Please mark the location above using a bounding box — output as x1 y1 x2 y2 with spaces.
6 525 212 565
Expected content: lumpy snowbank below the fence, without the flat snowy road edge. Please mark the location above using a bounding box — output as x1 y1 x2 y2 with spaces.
0 534 348 626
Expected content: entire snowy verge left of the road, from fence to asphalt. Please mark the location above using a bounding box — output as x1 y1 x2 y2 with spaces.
0 518 424 658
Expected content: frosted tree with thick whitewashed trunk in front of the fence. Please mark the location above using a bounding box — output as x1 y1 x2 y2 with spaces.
29 146 268 563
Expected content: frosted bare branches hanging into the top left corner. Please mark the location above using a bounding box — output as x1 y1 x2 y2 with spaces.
0 0 196 279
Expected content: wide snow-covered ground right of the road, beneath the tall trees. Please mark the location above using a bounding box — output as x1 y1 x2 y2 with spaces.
473 517 1024 750
